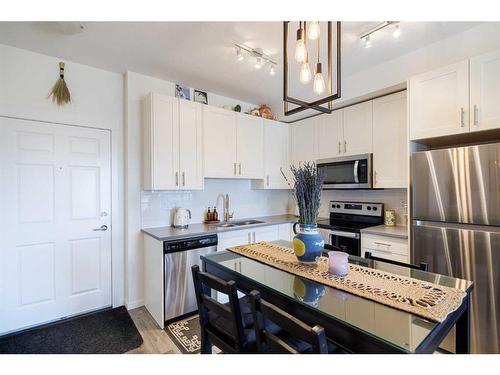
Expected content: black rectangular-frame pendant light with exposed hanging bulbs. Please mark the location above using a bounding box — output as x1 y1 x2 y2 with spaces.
283 21 341 116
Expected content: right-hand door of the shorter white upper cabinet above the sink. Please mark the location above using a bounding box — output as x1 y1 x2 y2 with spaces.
235 113 264 178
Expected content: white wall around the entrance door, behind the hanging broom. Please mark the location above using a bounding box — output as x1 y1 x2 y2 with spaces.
0 45 124 306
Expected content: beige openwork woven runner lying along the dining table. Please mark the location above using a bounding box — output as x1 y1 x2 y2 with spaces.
228 242 466 322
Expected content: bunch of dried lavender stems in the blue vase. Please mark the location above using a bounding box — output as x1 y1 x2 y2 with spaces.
281 162 325 224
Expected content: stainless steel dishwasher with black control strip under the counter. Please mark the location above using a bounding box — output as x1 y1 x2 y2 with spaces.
163 234 217 321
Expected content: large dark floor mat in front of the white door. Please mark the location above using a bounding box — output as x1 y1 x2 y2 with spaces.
0 306 142 354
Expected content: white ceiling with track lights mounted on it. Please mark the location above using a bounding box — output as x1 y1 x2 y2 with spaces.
0 22 478 117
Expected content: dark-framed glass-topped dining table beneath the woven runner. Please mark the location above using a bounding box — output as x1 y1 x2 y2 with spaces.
201 241 473 354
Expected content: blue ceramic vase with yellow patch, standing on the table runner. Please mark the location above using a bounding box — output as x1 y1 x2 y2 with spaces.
293 223 325 263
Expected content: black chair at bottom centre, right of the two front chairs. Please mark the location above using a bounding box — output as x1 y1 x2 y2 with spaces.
250 290 345 354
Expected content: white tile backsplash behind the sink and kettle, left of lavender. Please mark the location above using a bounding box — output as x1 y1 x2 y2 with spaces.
141 179 291 228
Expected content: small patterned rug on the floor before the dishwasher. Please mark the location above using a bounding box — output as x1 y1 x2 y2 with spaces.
165 315 201 354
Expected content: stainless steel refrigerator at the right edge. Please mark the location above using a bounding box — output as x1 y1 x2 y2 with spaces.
411 143 500 353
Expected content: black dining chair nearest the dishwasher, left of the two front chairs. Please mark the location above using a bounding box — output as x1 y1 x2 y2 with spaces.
192 266 256 354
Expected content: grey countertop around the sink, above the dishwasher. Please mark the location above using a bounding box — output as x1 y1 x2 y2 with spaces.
142 215 298 241
